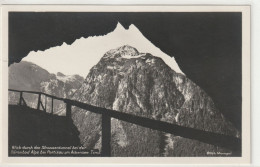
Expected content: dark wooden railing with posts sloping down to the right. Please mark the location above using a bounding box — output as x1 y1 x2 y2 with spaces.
9 89 241 156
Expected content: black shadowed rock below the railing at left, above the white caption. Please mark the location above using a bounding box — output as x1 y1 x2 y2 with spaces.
8 105 81 156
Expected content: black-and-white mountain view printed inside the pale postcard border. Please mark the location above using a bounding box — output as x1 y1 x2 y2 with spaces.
1 6 250 164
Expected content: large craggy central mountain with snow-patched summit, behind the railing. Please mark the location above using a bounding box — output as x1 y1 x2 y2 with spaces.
72 45 240 156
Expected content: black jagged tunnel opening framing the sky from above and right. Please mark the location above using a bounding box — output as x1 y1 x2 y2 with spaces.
9 12 242 130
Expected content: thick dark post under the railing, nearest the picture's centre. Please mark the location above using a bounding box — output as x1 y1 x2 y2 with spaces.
101 113 111 157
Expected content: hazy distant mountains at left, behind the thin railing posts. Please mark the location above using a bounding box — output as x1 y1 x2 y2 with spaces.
8 61 84 115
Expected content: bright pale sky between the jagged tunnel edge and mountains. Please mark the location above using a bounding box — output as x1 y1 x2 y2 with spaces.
22 23 183 77
